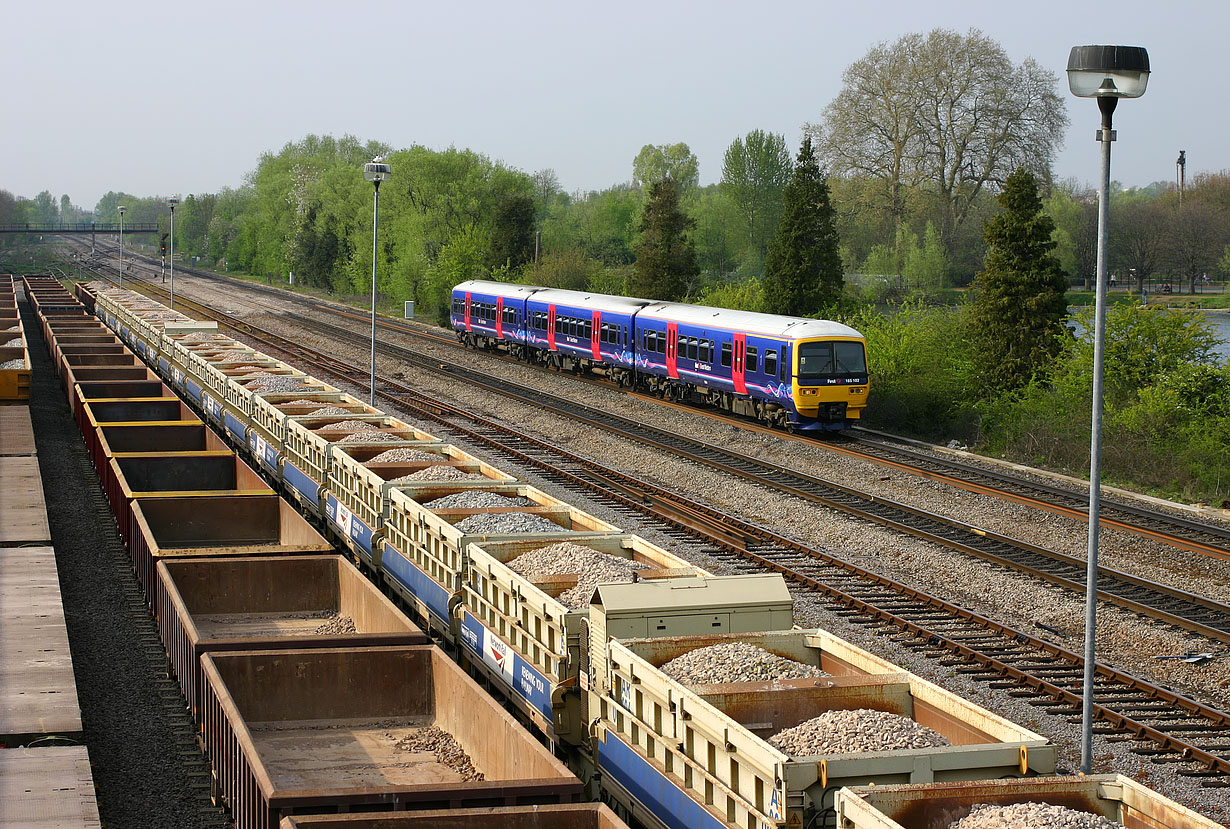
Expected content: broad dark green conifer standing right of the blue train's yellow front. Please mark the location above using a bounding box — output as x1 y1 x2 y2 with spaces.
970 167 1068 390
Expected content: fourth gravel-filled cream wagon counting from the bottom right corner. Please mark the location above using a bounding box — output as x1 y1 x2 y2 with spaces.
381 482 620 631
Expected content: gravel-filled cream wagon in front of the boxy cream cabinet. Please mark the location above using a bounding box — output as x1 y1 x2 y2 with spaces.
597 637 1055 827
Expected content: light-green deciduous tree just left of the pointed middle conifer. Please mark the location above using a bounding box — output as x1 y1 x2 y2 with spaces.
722 129 791 261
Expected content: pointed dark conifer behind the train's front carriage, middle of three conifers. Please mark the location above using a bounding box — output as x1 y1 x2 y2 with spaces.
763 138 844 316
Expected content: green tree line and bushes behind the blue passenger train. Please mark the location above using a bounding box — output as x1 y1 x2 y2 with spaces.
7 30 1230 492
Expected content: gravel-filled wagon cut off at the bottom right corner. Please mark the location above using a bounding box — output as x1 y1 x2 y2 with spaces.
836 775 1221 829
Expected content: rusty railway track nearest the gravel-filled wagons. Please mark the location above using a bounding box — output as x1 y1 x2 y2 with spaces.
81 263 1230 786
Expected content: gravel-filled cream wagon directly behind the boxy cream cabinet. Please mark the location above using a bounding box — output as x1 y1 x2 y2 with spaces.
460 533 702 744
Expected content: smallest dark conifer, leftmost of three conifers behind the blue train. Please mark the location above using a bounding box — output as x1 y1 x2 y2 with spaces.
632 176 700 300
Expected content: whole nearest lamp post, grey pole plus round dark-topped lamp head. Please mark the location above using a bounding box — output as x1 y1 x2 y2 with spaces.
1068 46 1149 774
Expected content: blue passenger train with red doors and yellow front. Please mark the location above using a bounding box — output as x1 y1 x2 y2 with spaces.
450 279 868 430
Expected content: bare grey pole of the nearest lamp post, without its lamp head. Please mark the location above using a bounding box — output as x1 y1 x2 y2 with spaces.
1080 95 1119 774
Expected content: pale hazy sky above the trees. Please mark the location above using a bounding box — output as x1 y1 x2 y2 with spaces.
0 0 1230 208
